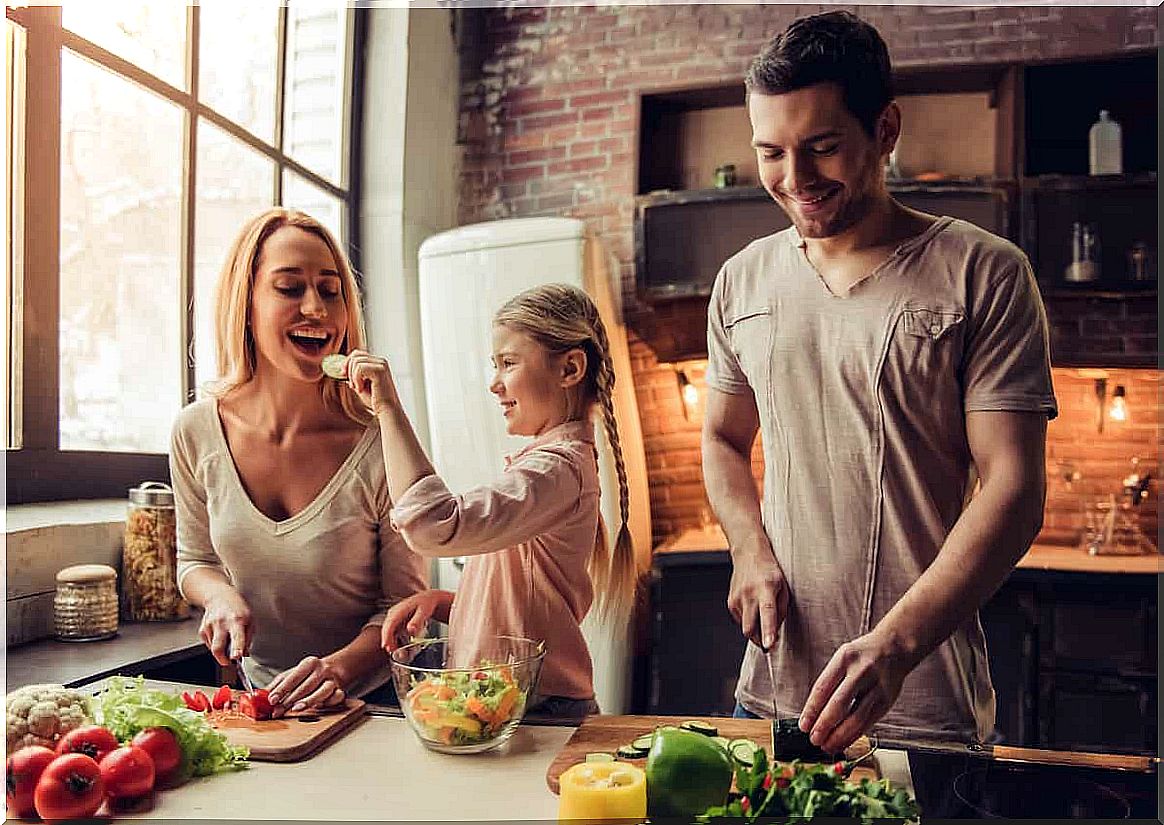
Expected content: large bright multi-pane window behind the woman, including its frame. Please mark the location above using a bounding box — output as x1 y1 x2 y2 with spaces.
3 0 360 503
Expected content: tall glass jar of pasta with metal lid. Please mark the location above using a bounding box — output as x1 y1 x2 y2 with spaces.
121 482 190 621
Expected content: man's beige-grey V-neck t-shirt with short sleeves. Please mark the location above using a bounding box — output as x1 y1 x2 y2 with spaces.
707 218 1057 739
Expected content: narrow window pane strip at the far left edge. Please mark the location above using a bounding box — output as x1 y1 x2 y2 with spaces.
0 19 24 449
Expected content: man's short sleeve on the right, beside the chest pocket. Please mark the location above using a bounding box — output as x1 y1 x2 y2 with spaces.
963 256 1058 419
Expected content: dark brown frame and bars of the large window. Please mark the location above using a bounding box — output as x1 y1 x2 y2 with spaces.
5 3 367 505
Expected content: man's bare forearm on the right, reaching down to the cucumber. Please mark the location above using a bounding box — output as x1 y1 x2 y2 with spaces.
874 481 1044 664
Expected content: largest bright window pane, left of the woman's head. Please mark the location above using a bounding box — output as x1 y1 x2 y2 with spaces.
61 50 183 453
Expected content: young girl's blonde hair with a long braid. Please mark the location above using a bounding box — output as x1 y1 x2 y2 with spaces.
494 284 637 620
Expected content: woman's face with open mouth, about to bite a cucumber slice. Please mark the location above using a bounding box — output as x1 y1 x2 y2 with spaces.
250 226 348 382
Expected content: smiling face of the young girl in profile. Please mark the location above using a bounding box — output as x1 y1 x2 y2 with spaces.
489 325 576 435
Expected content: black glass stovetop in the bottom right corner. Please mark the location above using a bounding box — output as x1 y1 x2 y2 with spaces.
909 752 1158 823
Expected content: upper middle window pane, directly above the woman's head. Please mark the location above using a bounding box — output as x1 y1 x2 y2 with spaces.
198 2 279 143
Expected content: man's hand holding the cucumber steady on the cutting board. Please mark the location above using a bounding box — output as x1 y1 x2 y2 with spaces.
800 630 917 753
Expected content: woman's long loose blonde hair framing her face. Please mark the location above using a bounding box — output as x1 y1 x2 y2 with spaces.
211 206 371 426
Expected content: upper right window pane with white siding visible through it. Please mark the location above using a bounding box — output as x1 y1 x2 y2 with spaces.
283 3 349 185
